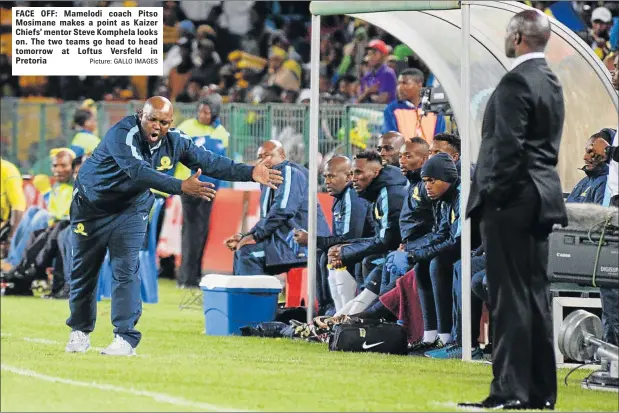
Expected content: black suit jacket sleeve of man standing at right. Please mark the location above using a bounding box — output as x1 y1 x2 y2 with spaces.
485 74 532 206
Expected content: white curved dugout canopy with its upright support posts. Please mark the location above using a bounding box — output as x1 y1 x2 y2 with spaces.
308 0 619 360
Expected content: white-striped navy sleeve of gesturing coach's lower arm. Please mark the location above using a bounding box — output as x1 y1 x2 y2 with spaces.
108 129 182 194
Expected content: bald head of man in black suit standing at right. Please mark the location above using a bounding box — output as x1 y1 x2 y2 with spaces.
505 10 551 58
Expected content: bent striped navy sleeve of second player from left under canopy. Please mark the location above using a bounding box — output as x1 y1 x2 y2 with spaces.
341 189 403 264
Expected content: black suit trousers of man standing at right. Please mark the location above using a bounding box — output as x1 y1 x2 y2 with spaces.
481 182 557 404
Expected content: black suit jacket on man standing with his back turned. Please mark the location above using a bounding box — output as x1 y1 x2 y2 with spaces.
466 59 567 226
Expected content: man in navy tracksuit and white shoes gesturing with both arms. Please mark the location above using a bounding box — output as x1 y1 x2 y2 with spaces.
66 96 281 355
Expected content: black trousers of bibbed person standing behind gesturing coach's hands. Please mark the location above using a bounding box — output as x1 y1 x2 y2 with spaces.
178 195 213 287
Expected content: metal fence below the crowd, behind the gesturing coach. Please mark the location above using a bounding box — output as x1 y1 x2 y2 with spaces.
0 98 384 174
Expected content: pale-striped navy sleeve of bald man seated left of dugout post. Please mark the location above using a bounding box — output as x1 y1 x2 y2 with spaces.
250 165 307 242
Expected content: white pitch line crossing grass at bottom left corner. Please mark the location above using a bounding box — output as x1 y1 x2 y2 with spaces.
0 364 249 412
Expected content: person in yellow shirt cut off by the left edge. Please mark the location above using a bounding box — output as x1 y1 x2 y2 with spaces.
0 159 26 260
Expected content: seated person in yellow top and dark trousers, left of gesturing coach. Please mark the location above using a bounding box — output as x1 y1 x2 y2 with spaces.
5 148 75 294
